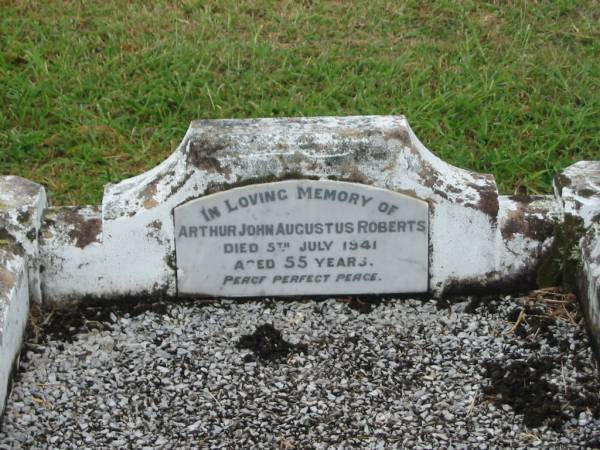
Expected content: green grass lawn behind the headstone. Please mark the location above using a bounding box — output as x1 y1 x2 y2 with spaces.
0 0 600 204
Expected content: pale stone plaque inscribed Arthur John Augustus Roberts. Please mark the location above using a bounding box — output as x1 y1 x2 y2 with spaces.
174 180 428 297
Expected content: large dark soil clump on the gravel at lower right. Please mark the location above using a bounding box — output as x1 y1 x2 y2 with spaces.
483 358 568 430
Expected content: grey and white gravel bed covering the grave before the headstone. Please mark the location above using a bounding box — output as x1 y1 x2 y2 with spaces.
0 297 600 449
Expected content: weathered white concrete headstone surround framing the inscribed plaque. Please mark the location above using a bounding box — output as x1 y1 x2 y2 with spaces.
41 116 560 302
